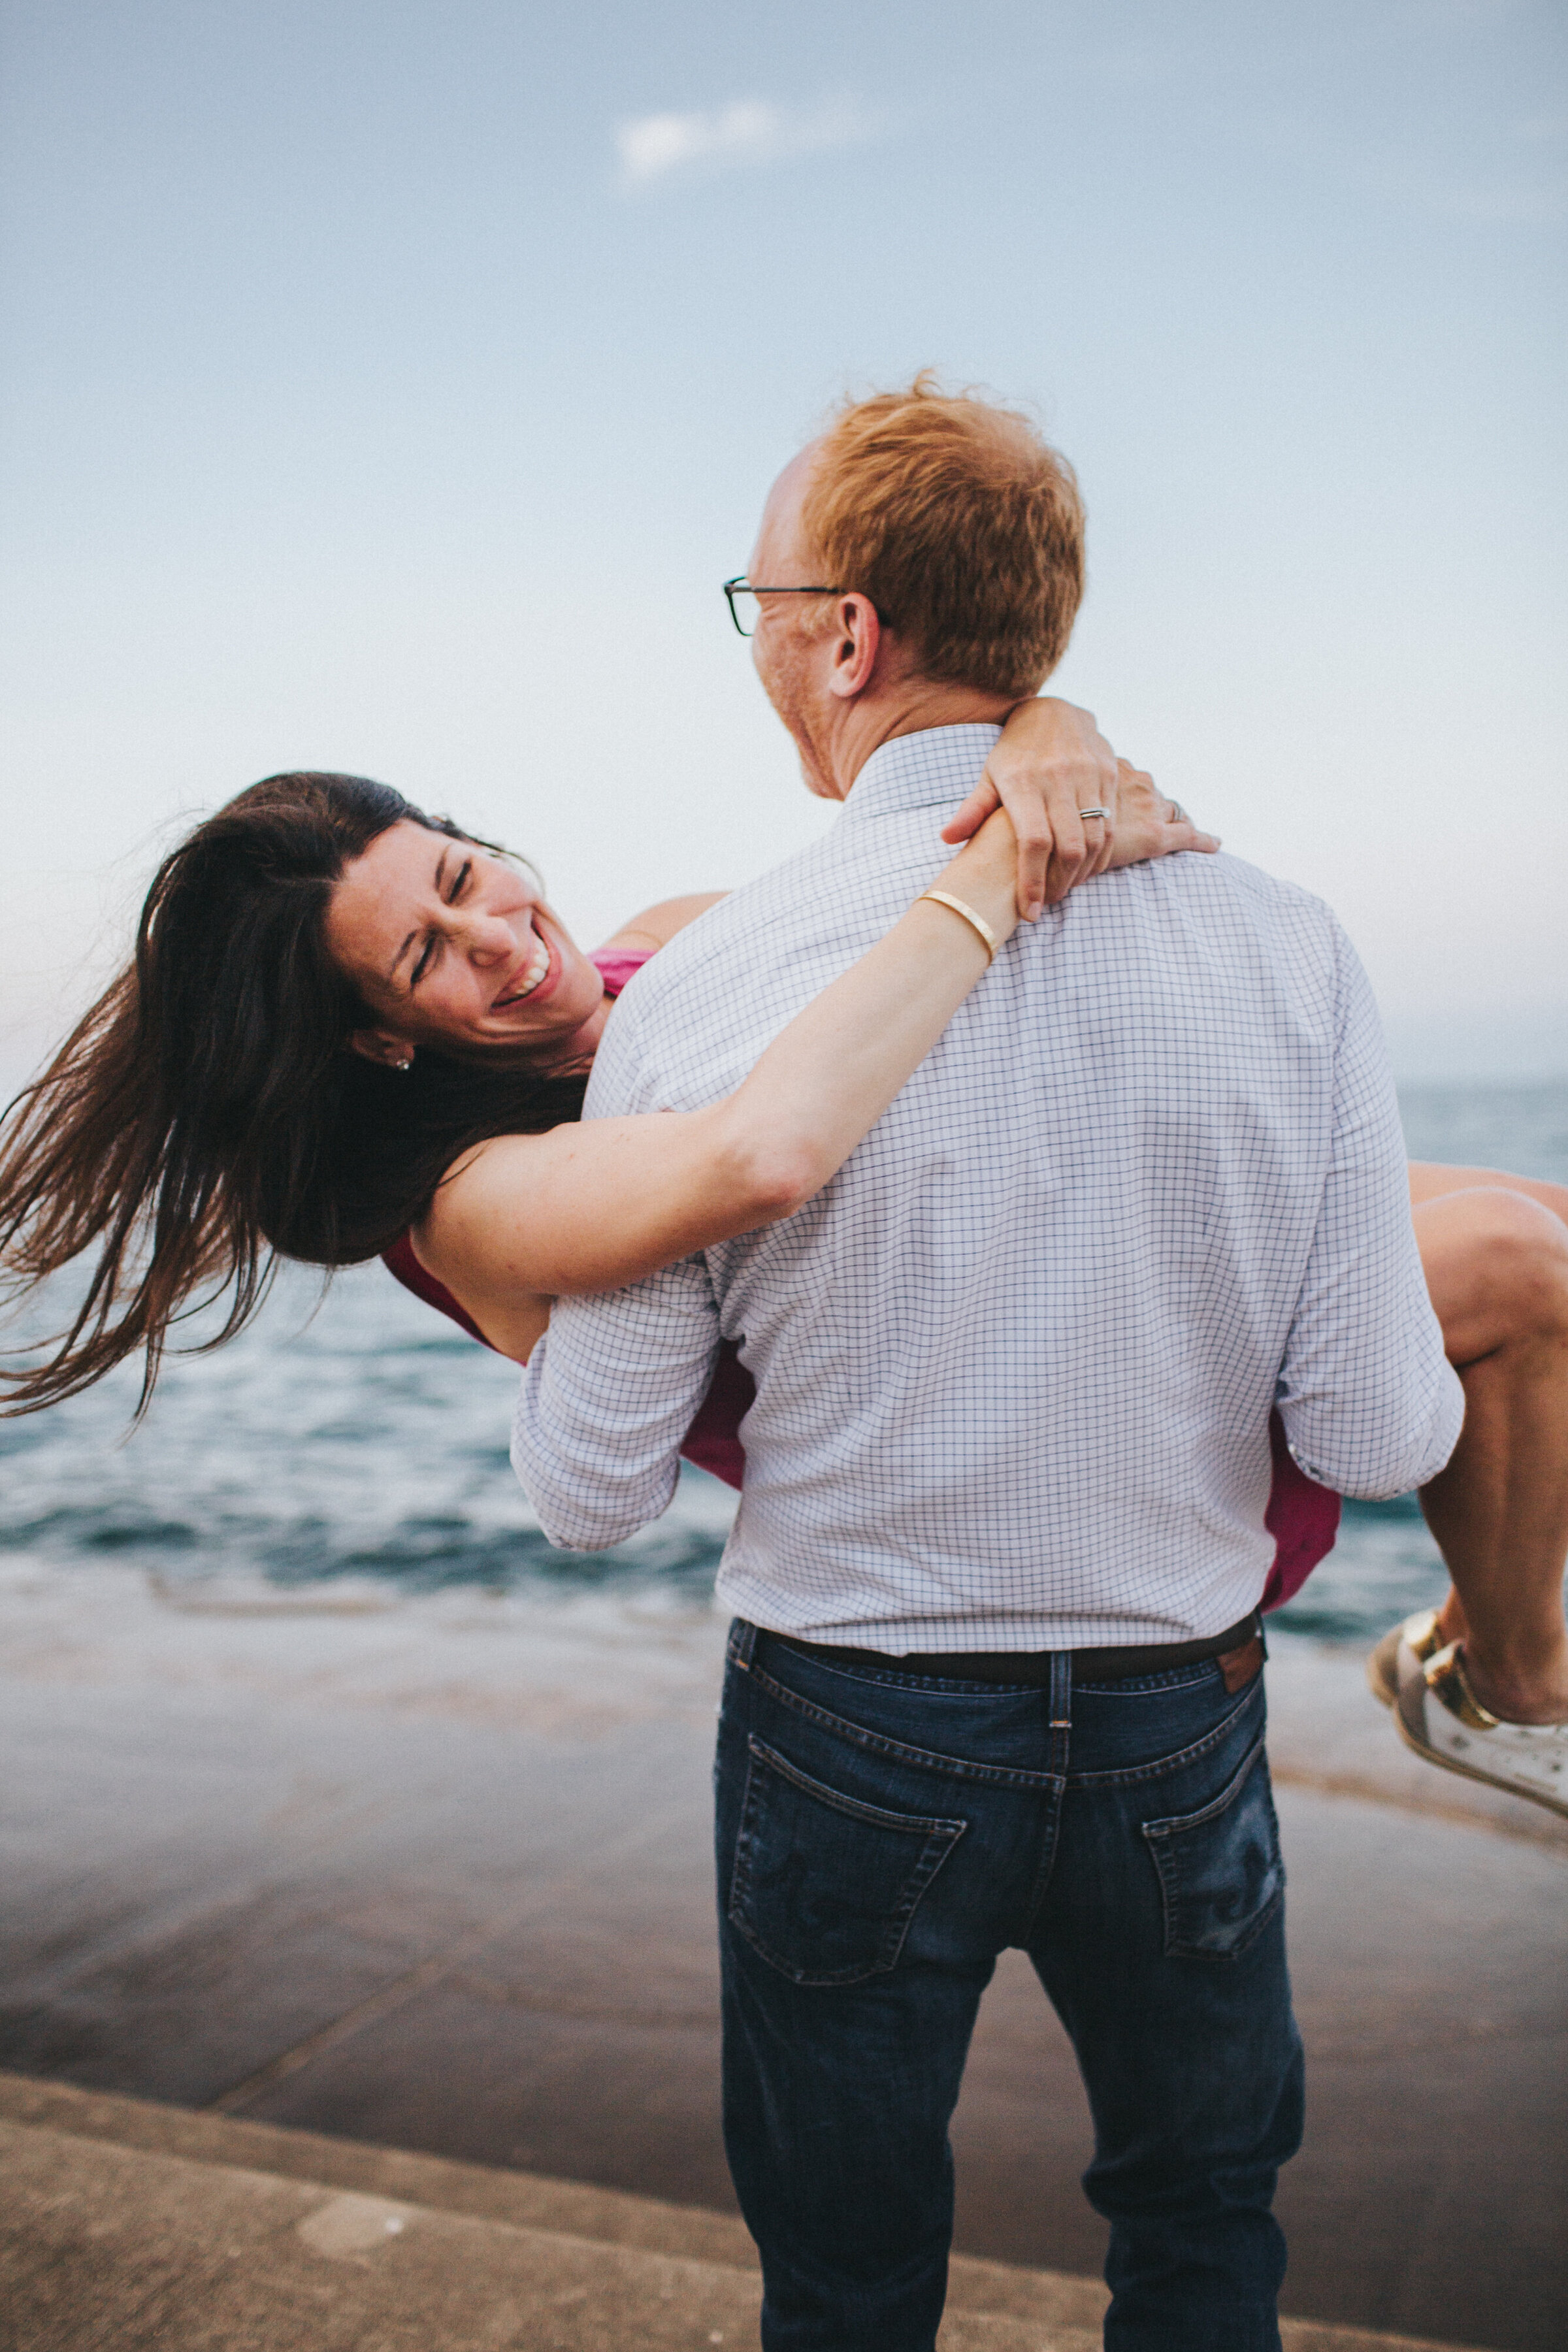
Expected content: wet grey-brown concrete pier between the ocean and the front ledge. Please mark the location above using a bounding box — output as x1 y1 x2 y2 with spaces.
0 1569 1568 2352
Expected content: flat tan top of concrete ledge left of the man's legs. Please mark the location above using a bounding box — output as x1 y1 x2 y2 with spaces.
0 2124 757 2352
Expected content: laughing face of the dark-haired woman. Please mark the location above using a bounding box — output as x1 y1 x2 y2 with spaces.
327 819 604 1063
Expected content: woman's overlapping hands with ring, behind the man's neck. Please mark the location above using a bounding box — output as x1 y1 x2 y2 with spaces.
943 694 1218 922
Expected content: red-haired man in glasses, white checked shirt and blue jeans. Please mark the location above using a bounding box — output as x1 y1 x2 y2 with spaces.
512 379 1462 2352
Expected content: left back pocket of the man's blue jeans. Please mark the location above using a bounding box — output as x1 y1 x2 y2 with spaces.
728 1736 966 1985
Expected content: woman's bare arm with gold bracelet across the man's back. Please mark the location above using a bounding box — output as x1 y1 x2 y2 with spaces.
414 816 1018 1355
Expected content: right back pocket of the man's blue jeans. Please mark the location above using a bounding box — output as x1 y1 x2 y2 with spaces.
1143 1740 1286 1959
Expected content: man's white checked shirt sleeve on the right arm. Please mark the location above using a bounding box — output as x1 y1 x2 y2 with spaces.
1279 926 1465 1501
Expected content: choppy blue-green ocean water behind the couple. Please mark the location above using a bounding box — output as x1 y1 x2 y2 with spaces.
0 1082 1568 1642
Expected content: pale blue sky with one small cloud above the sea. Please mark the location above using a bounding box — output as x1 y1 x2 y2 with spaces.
0 0 1568 1079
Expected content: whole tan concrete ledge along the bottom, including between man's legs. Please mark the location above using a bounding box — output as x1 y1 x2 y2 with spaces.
0 2074 1495 2352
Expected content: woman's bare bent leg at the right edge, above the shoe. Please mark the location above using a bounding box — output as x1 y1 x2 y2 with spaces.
1411 1164 1568 1724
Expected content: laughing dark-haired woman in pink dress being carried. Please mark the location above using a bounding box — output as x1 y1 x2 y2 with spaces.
0 724 1568 1802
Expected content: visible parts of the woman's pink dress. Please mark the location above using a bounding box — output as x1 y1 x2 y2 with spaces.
381 948 1340 1609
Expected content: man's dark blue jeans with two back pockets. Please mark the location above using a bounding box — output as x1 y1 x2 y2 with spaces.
715 1620 1302 2352
